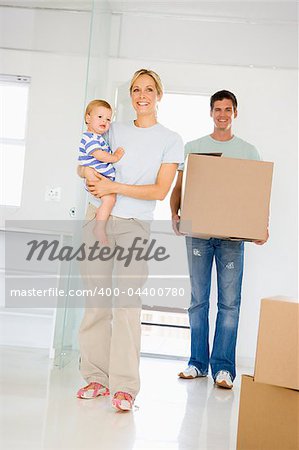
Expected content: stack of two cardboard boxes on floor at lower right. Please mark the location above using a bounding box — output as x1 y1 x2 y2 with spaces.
237 298 299 450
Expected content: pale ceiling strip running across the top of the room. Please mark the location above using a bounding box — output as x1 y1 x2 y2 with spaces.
0 0 298 23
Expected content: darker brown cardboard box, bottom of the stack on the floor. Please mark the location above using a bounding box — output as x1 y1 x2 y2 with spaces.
237 375 299 450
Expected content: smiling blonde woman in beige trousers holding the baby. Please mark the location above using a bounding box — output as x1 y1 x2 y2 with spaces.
77 69 184 411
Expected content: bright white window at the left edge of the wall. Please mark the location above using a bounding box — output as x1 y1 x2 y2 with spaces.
0 75 30 206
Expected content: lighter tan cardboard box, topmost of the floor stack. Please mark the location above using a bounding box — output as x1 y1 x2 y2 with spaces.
254 297 299 388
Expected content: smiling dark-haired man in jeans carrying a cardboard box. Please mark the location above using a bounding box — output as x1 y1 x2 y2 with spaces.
170 90 266 389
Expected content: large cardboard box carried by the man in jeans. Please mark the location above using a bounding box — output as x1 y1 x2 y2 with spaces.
180 154 273 241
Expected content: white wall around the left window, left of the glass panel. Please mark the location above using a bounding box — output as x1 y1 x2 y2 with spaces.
0 7 91 220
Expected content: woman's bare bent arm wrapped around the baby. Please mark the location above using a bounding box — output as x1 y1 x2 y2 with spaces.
86 163 178 200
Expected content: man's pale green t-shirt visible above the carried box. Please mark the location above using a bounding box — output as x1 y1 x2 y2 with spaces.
179 135 261 170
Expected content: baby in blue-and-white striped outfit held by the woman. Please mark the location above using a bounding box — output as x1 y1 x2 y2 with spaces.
79 100 124 244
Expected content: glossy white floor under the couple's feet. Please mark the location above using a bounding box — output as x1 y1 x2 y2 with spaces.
0 347 254 450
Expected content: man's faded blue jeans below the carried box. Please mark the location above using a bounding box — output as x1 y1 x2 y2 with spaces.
186 237 244 379
